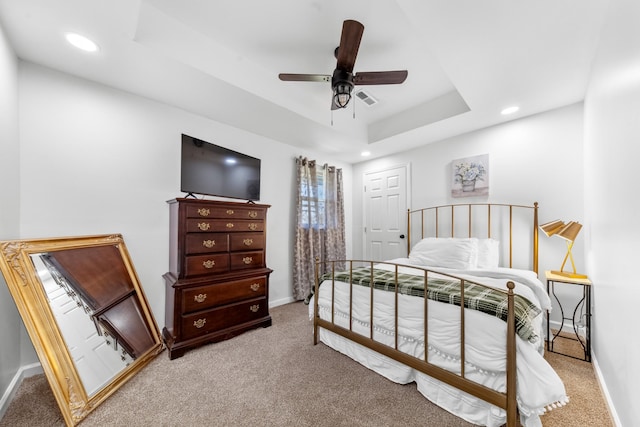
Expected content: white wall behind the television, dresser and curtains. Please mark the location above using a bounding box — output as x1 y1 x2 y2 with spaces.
15 62 351 327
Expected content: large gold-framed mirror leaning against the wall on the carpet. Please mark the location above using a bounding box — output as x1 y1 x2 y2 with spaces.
0 234 163 426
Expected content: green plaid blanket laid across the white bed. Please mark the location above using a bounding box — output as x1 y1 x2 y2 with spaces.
321 267 541 342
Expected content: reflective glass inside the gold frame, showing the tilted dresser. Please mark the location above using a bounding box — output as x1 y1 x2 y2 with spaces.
31 246 154 396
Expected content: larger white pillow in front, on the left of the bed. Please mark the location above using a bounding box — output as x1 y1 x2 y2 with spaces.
409 237 478 270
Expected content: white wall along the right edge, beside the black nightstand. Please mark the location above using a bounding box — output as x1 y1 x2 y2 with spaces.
584 0 640 426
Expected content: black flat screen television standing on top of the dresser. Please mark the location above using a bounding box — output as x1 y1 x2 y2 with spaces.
180 134 260 201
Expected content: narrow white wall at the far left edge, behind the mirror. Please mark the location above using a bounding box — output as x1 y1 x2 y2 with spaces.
0 19 26 408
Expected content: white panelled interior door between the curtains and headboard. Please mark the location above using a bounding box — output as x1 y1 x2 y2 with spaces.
364 166 407 261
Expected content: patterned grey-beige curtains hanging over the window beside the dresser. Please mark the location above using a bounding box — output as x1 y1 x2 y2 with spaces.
293 157 346 300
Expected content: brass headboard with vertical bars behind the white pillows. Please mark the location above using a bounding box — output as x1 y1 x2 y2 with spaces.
407 202 538 273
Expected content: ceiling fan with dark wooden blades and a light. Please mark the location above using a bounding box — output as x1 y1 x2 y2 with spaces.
278 19 408 110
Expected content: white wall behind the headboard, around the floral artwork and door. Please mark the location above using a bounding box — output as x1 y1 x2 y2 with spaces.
353 103 585 284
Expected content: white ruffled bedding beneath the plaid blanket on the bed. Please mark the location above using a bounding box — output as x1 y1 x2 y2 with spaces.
309 258 568 427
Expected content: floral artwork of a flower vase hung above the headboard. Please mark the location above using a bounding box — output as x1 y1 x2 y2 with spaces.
451 154 489 197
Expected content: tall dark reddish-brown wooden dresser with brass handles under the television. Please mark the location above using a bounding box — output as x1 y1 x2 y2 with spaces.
162 198 272 359
